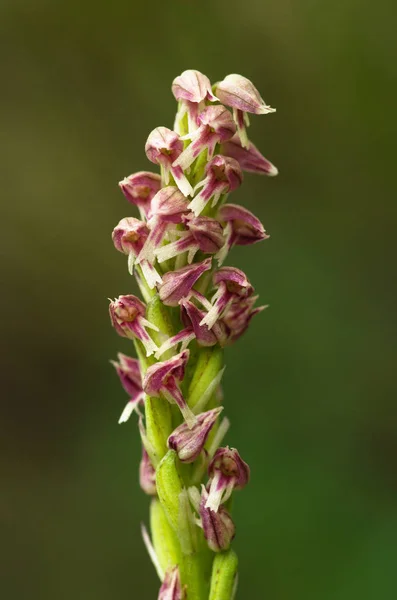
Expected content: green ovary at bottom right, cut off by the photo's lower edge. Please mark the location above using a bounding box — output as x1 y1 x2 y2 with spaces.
208 550 238 600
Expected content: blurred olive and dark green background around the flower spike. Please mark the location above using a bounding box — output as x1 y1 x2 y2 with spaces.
0 0 397 600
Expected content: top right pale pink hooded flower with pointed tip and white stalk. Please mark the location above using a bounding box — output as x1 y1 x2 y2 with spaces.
215 74 276 148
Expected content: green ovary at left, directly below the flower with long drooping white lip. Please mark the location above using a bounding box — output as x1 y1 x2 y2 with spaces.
145 396 172 467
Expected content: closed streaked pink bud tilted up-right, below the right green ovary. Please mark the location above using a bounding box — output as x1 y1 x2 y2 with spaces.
167 407 223 463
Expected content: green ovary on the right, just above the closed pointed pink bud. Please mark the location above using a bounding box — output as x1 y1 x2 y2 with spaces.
187 346 223 408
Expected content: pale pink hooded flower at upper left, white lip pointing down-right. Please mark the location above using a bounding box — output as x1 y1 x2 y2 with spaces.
145 127 193 196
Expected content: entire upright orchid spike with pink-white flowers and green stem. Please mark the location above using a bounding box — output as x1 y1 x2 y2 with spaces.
110 70 277 600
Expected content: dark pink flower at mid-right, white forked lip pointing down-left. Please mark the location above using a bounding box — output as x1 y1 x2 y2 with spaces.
200 267 254 329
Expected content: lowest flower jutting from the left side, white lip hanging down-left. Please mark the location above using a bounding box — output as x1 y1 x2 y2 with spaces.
110 352 145 423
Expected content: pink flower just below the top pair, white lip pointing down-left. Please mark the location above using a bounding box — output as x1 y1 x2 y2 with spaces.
173 105 236 171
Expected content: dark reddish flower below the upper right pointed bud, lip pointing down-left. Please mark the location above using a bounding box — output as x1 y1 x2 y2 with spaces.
189 155 243 215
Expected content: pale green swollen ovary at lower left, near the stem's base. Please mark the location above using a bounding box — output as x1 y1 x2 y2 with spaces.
150 498 181 572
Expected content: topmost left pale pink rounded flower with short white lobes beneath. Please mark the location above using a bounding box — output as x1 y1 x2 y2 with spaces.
172 69 218 134
